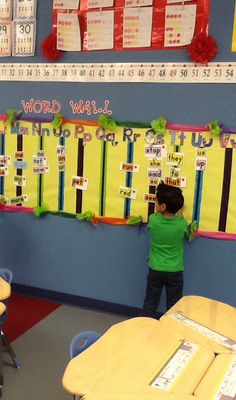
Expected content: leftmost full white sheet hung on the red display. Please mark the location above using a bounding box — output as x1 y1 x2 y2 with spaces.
57 13 81 51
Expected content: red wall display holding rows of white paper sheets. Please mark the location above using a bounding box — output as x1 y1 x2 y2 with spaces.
53 0 210 51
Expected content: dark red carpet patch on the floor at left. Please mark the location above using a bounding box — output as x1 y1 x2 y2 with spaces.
3 293 60 342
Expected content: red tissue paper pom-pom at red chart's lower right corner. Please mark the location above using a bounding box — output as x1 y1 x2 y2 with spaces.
187 33 218 64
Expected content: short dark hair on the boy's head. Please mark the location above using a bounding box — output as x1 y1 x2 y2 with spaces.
156 182 184 214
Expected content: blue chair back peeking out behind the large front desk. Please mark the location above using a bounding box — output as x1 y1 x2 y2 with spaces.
70 331 101 359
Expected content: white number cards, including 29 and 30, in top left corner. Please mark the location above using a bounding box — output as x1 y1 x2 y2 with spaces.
0 0 37 57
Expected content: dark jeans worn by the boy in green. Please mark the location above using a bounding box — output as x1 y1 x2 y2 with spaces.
143 268 184 317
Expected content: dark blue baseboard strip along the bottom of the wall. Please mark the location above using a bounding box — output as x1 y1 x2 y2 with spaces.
12 283 148 317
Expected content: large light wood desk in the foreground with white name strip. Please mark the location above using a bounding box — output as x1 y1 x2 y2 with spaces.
62 318 215 400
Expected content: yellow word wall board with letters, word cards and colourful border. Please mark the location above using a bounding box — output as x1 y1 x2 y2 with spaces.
0 114 236 239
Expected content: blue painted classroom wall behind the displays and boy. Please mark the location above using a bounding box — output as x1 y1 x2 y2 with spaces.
0 0 236 309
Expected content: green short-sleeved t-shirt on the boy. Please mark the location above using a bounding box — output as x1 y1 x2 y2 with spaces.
148 213 188 272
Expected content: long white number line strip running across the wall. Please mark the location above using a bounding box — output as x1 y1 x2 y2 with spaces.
0 62 236 83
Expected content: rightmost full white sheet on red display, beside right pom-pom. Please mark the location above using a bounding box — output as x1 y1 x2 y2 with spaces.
164 4 197 47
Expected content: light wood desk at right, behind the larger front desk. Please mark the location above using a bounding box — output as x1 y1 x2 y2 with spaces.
160 296 236 354
